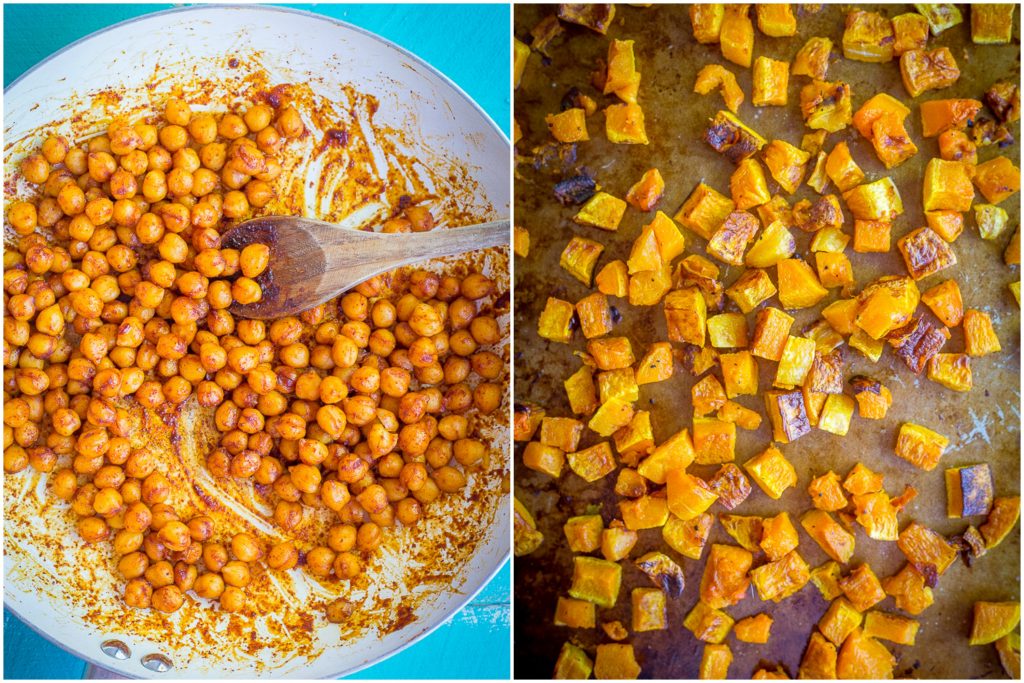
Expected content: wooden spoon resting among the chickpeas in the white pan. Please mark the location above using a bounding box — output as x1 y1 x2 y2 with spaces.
221 216 509 319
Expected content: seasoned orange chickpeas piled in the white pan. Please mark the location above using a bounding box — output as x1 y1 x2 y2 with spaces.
3 94 507 621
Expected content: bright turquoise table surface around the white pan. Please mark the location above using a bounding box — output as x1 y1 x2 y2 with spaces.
3 4 512 680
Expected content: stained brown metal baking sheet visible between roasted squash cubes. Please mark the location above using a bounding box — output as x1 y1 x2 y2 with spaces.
514 5 1020 679
